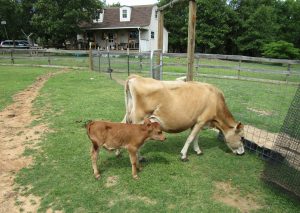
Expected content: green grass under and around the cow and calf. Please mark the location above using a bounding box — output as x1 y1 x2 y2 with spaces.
9 71 300 212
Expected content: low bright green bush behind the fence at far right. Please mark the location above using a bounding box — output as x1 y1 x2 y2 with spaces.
262 41 300 59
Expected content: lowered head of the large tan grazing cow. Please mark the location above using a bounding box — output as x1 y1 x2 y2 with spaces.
224 122 245 155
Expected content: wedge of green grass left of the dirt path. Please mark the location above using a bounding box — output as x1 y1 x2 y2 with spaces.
0 66 56 110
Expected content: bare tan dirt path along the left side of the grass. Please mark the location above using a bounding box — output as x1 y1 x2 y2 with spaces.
0 70 66 213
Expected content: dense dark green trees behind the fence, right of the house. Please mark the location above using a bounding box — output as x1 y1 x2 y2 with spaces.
160 0 300 56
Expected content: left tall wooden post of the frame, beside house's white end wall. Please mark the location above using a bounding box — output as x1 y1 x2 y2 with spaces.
154 11 164 79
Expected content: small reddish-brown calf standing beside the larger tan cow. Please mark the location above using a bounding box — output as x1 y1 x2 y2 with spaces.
86 119 166 179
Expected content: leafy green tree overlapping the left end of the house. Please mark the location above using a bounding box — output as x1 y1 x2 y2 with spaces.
32 0 102 47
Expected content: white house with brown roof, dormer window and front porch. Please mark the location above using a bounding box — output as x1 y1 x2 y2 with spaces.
81 4 168 52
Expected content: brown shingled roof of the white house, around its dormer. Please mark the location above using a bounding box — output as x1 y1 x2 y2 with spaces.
81 5 155 29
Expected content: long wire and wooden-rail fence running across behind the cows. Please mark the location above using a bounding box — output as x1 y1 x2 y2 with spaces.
0 49 300 193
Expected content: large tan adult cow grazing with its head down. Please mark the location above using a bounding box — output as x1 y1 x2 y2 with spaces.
123 75 244 160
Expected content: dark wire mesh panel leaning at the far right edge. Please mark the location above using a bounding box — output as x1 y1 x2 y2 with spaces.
264 87 300 196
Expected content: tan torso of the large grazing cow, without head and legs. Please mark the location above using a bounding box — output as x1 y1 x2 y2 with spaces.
126 76 224 132
